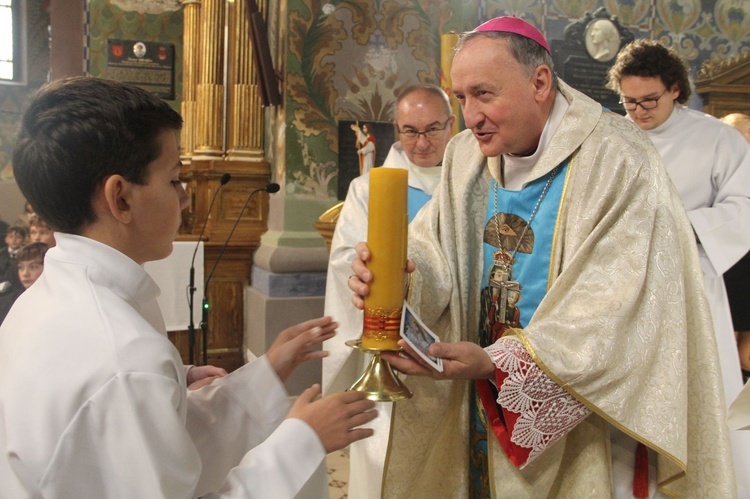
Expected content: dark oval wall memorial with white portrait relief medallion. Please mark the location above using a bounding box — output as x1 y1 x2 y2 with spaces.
550 7 634 114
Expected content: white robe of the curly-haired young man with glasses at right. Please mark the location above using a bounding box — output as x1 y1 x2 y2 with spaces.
646 105 750 497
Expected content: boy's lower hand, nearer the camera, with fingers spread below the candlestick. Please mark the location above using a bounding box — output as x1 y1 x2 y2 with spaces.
287 384 378 453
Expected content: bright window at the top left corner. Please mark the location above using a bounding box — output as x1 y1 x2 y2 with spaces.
0 0 26 83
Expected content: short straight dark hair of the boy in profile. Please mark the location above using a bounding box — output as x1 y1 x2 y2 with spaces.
13 77 182 234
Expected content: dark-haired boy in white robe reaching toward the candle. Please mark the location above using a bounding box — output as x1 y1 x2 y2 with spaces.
0 77 375 498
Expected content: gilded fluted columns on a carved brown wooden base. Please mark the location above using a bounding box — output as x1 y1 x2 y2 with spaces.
170 0 270 371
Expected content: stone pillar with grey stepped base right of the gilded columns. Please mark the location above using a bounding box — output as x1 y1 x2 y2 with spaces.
245 0 335 394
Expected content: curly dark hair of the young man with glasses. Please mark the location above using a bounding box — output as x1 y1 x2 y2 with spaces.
607 39 691 104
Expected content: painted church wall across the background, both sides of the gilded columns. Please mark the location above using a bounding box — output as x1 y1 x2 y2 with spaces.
0 0 750 218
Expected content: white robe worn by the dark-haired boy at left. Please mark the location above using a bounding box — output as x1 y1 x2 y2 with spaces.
0 233 325 499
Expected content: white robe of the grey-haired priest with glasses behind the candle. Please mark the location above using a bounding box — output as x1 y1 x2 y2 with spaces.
323 142 441 499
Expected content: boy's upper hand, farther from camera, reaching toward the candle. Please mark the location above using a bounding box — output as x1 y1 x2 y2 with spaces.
266 317 338 381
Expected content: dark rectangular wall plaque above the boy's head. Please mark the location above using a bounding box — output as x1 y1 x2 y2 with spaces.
106 40 174 100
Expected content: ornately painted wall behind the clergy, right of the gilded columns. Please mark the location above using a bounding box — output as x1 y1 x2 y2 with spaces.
280 0 750 210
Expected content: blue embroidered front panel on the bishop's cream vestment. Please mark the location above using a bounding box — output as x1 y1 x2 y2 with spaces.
469 160 568 498
